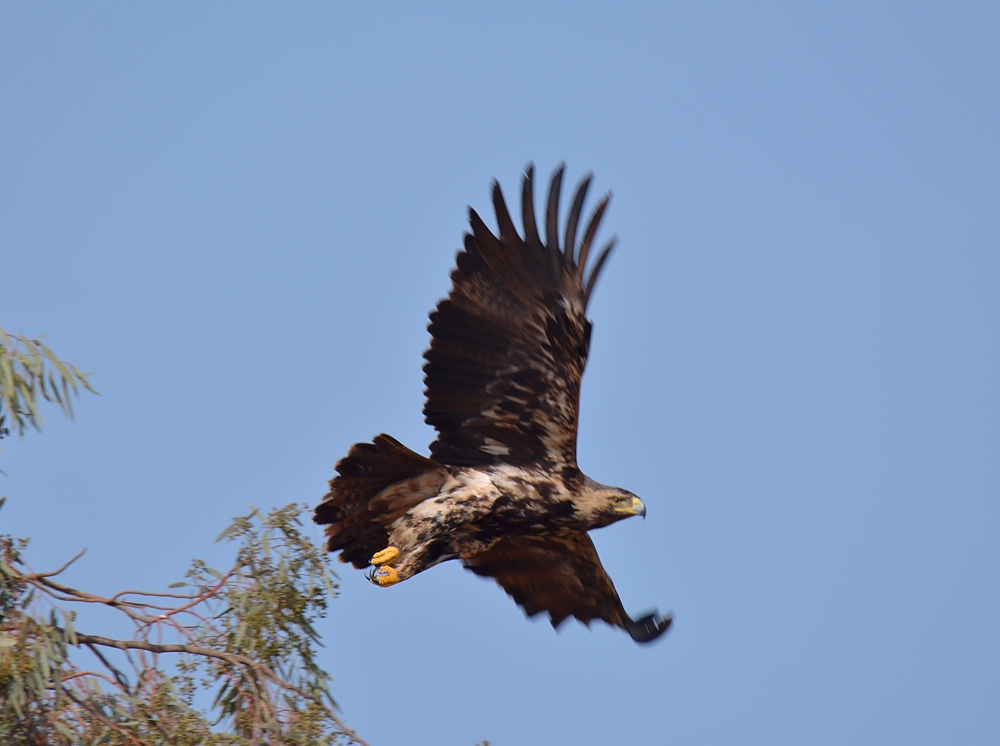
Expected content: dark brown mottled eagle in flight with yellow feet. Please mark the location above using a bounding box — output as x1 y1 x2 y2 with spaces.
314 165 673 643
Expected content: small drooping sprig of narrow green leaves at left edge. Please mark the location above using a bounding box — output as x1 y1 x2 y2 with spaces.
0 328 97 448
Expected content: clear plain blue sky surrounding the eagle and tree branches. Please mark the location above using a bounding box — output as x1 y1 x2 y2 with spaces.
0 2 1000 746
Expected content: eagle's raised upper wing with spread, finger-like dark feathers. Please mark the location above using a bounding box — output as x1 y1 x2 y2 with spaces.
424 166 613 469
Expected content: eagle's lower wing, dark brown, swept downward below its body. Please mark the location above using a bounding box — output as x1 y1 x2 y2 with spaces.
462 531 673 642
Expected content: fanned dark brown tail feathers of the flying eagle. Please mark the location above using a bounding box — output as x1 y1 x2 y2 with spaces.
314 434 442 569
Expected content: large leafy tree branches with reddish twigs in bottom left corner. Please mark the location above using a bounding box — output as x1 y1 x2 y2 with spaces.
0 501 364 746
